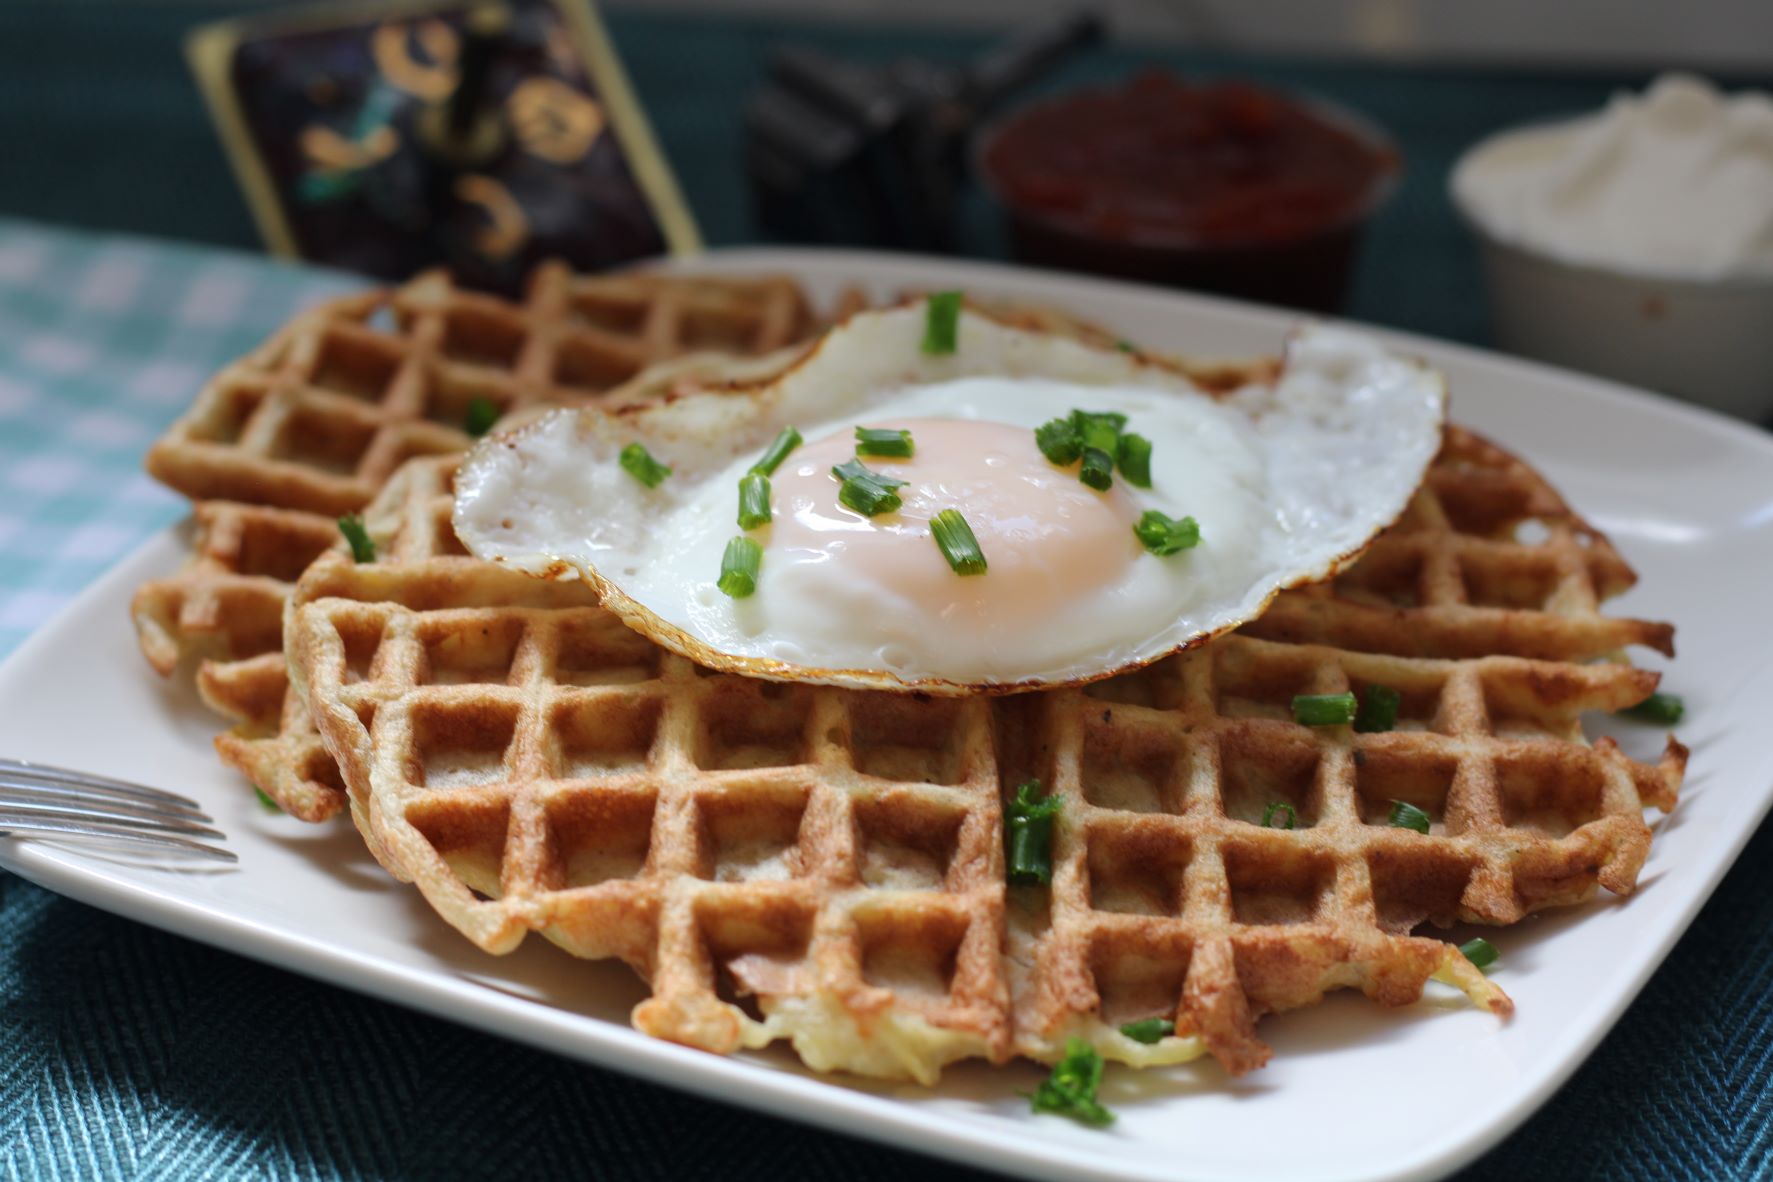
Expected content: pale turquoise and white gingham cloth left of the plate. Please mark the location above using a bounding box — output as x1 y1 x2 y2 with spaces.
0 222 360 656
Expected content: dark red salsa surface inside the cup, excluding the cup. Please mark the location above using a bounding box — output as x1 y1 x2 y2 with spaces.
982 71 1397 246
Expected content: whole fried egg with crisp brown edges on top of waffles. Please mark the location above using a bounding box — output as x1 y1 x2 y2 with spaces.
454 303 1445 693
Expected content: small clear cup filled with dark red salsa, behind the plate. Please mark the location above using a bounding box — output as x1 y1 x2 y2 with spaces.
975 73 1399 312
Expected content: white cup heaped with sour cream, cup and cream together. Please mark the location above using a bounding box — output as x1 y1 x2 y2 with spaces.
1450 74 1773 420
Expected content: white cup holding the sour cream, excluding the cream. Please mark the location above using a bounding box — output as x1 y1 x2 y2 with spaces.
1449 133 1773 422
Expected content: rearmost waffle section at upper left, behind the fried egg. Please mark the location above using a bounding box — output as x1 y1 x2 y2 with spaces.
147 264 817 514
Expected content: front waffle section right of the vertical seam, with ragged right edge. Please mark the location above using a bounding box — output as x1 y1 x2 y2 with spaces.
998 633 1686 1070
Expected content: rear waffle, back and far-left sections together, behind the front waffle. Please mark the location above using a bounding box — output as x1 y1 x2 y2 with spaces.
133 266 829 820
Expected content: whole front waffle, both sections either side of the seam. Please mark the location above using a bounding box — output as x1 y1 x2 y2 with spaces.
285 431 1684 1083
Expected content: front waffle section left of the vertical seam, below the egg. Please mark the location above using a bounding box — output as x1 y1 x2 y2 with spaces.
289 461 1011 1077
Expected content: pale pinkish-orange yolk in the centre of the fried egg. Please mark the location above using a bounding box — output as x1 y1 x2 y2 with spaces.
766 418 1140 634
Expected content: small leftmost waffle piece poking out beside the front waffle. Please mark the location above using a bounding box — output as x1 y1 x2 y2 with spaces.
131 502 344 820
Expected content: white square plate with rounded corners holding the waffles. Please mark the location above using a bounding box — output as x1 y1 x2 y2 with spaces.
0 250 1773 1182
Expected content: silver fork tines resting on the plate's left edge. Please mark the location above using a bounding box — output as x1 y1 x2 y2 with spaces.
0 758 239 861
